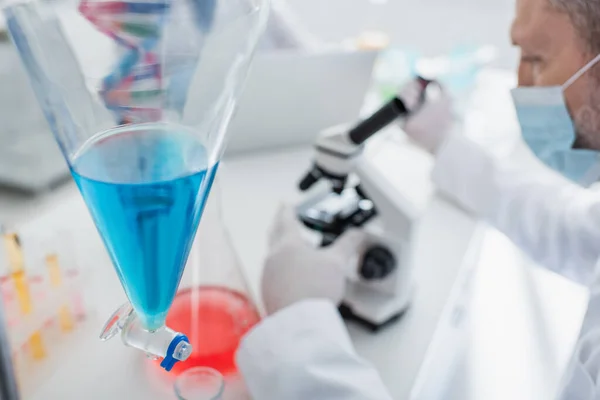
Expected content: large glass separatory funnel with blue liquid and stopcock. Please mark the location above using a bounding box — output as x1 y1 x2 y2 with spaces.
5 0 268 371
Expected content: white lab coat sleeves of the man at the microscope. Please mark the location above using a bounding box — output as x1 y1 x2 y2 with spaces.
237 131 600 400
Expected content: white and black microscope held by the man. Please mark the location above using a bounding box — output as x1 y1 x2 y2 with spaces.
296 77 439 332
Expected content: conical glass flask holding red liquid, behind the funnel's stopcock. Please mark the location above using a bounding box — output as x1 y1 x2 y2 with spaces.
157 178 262 381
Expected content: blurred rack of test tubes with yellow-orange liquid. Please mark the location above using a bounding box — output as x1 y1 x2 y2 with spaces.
0 228 94 398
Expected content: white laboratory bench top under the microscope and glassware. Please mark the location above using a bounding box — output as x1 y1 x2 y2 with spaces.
0 72 587 400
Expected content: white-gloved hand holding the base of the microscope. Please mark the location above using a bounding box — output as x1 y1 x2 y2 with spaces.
261 206 366 315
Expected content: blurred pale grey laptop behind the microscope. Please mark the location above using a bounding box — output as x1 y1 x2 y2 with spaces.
226 50 378 155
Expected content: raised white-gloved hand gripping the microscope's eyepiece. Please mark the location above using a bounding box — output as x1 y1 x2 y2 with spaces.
399 81 454 154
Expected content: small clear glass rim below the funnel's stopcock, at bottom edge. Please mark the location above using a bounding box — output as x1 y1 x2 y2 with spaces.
175 367 225 400
